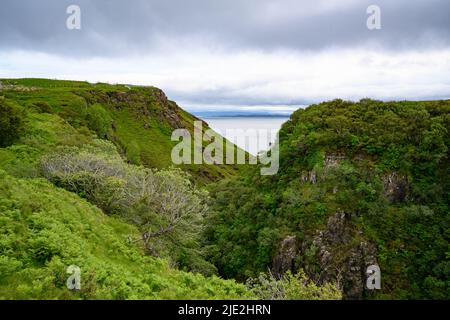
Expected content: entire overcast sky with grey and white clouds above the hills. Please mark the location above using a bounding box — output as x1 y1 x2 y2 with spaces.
0 0 450 110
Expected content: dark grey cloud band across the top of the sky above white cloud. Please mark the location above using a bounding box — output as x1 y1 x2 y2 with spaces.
0 0 450 56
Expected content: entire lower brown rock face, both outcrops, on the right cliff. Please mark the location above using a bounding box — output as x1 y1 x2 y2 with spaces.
272 212 378 299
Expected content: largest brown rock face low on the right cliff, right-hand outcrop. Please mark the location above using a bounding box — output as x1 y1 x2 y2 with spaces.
305 212 377 299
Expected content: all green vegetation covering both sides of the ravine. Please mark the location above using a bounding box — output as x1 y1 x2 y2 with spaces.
0 79 450 299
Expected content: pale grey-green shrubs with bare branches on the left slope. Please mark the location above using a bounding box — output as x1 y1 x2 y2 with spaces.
41 141 215 274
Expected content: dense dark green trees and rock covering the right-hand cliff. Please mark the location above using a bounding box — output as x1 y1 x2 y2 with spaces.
206 100 450 299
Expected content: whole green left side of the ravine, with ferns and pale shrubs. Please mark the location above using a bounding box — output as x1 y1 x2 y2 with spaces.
0 79 341 299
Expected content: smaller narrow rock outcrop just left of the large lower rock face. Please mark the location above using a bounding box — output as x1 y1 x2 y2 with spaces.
272 236 298 278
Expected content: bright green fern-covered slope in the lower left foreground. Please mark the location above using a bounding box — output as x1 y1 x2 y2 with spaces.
0 171 250 299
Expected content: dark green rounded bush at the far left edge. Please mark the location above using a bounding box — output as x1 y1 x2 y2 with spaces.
0 99 25 147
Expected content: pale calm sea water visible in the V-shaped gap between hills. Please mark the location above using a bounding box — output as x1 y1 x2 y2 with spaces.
201 116 289 155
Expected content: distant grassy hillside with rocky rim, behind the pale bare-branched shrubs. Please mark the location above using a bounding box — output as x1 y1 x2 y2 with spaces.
0 79 246 183
